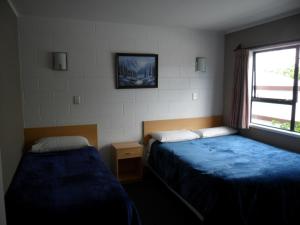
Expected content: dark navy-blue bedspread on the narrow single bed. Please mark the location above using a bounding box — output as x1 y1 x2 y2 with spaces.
6 147 140 225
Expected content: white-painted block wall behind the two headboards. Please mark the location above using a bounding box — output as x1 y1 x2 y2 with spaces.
19 17 224 164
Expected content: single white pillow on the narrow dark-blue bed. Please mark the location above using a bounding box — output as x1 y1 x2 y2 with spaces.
31 136 90 152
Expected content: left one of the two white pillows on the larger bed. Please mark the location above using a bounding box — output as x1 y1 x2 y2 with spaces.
151 130 200 142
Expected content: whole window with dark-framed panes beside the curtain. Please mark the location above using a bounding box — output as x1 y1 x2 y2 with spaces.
251 45 300 133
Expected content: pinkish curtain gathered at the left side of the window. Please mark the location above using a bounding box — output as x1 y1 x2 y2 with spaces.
230 48 249 129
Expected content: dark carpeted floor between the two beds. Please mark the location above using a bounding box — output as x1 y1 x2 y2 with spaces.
123 172 202 225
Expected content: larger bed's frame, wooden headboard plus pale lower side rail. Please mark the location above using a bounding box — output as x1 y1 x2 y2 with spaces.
143 116 223 222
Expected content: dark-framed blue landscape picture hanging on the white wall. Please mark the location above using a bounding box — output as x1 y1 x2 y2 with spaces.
116 53 158 89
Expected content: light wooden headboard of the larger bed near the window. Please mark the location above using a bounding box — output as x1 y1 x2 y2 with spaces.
143 116 223 144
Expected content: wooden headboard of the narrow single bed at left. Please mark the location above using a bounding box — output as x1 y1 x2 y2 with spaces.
24 124 98 150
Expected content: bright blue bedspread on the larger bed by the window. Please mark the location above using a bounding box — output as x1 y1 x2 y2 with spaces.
148 135 300 224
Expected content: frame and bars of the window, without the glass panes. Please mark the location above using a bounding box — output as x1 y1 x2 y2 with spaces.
250 43 300 133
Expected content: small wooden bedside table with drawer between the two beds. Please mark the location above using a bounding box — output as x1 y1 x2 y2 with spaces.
112 142 143 182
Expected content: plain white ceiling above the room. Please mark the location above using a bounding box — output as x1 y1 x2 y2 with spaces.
10 0 300 32
